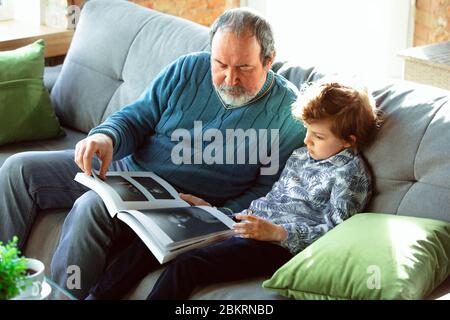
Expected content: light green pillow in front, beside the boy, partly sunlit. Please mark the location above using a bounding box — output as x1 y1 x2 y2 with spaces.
263 213 450 299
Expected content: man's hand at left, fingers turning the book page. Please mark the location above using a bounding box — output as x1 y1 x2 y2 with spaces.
75 133 113 179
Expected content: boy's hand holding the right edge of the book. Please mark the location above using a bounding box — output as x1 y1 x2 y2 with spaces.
233 214 287 241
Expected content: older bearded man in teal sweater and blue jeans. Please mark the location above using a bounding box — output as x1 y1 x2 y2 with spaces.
0 9 305 298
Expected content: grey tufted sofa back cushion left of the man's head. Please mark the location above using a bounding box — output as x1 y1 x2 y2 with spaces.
51 0 209 133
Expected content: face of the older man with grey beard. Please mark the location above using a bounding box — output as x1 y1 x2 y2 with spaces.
211 30 273 107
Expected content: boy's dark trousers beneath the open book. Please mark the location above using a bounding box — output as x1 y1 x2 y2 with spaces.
90 237 292 300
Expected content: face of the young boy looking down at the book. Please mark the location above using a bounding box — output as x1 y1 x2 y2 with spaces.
304 119 351 160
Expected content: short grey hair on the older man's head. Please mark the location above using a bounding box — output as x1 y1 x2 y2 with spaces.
210 8 275 66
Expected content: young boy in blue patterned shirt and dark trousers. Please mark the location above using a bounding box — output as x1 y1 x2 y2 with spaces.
88 82 380 299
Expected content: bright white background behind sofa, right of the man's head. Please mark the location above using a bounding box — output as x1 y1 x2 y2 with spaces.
243 0 414 78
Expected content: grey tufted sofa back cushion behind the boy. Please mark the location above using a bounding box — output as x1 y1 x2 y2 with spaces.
277 64 450 221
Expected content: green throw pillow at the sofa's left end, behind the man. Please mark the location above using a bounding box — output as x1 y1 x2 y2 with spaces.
0 40 64 145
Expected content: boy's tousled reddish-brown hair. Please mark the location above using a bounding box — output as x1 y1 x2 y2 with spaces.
293 82 382 150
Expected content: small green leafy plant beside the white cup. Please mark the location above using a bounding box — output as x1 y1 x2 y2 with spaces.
0 236 27 300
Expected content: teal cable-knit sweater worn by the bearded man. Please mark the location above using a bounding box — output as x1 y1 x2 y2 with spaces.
89 52 305 212
